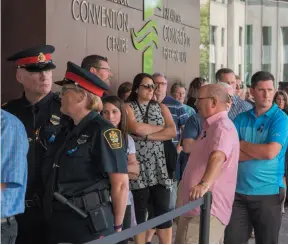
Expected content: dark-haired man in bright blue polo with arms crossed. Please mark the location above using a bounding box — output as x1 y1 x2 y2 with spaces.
224 71 288 243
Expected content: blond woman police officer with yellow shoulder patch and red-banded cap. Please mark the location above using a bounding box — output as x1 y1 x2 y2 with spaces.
43 62 129 243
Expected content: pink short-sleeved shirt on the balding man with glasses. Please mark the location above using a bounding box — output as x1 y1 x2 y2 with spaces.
182 111 240 225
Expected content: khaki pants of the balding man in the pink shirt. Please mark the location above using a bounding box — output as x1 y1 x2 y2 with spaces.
175 216 226 244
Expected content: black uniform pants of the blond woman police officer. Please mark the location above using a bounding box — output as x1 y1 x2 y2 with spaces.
47 204 114 244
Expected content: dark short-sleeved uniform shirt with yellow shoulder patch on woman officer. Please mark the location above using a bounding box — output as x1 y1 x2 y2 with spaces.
43 111 128 197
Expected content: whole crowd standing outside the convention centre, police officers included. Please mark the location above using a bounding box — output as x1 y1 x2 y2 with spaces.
1 45 288 244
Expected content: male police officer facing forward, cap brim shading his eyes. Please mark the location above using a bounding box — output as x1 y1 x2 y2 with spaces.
2 45 67 243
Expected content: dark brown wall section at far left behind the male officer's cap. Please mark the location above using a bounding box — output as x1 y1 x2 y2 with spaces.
1 0 46 101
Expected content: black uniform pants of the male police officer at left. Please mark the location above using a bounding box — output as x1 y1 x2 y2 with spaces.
16 207 47 244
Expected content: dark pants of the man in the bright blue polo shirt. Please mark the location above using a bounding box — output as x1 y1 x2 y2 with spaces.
224 188 284 244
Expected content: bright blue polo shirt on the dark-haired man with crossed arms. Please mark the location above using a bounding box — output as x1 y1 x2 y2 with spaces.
234 104 288 195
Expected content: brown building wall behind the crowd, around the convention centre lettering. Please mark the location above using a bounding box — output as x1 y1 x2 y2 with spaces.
2 0 200 100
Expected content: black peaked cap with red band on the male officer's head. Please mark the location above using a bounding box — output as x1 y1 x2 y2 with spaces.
7 45 56 72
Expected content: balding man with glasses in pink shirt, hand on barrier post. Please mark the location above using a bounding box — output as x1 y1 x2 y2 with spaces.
175 84 239 244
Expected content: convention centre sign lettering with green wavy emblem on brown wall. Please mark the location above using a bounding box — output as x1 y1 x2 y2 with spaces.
71 0 195 74
